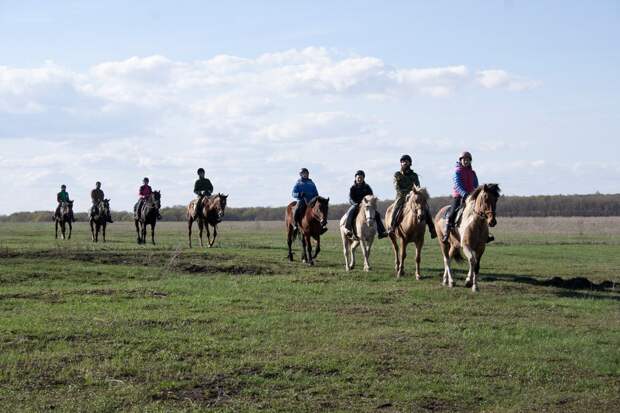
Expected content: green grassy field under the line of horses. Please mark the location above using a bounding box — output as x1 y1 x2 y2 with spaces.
0 218 620 412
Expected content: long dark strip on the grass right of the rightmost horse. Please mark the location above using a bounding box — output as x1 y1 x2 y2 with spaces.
482 274 620 300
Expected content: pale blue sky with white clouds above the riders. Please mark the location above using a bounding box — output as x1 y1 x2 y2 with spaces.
0 0 620 214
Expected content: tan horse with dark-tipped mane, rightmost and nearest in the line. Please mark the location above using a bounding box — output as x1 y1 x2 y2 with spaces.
435 184 501 291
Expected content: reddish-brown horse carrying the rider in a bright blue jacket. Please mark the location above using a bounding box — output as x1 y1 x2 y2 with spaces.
284 196 329 265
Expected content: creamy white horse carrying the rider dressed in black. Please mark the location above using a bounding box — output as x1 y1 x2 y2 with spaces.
340 195 377 271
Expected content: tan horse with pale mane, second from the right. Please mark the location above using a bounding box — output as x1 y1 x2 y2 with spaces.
385 186 429 280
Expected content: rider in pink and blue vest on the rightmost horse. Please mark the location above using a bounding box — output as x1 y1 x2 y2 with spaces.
441 151 495 242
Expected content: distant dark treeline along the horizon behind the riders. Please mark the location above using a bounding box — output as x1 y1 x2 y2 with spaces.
0 194 620 222
